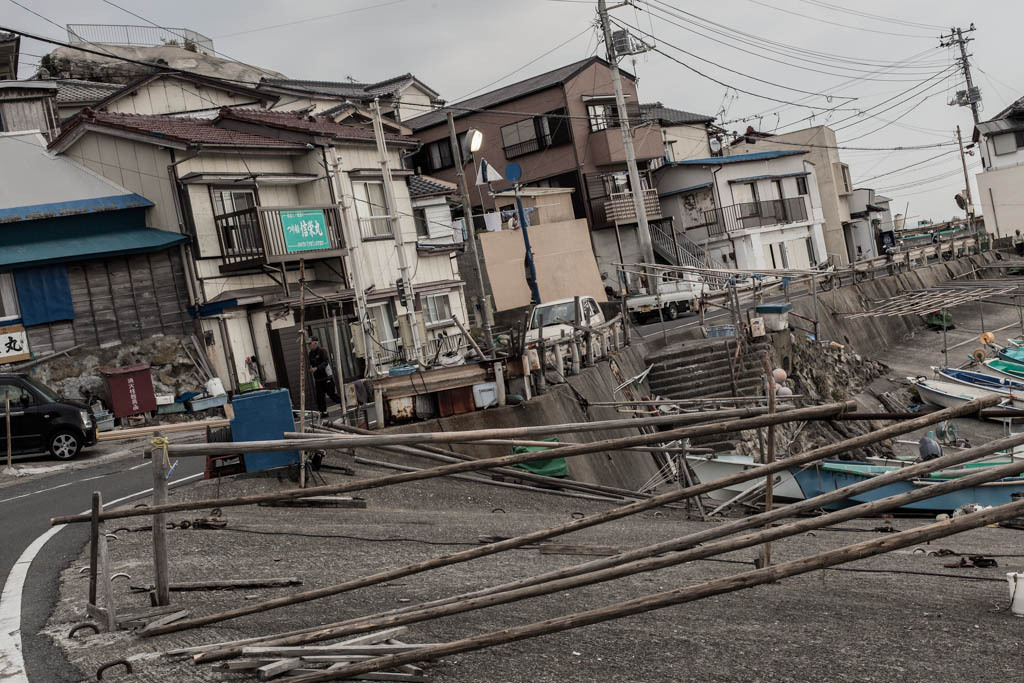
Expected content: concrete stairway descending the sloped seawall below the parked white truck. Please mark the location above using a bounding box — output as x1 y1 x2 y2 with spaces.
646 339 771 453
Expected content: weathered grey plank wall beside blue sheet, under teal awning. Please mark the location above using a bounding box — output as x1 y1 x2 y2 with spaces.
28 250 193 356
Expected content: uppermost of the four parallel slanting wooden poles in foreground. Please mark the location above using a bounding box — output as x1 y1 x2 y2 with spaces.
141 396 978 635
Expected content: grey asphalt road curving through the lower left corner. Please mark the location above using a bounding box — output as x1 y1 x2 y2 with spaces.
0 450 204 683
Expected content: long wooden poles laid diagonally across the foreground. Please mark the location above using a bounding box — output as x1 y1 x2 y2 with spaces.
52 396 1024 683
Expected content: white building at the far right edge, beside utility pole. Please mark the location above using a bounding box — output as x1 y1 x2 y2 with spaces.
974 97 1024 238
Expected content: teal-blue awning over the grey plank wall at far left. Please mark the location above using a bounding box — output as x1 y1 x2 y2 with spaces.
0 227 188 269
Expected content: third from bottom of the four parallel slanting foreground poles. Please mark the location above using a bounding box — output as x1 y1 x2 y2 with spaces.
196 434 1024 663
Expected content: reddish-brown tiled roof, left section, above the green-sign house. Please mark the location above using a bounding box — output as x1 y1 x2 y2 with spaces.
50 108 304 150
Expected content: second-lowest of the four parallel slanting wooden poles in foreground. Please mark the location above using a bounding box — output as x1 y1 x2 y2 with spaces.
205 448 1024 663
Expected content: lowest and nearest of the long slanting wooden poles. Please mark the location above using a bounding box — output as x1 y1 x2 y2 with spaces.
292 501 1024 683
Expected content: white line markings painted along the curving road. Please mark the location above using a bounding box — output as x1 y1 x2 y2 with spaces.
0 473 203 683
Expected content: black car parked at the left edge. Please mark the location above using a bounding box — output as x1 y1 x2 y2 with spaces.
0 373 96 460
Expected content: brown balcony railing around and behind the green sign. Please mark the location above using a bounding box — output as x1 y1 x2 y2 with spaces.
213 206 345 265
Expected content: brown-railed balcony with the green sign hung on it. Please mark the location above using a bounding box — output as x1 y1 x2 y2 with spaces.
213 206 346 272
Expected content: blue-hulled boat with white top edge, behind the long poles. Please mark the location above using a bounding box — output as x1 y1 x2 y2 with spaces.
790 460 1024 514
